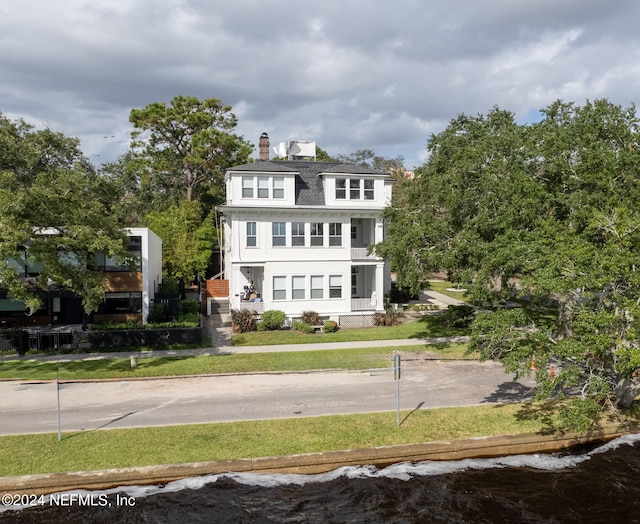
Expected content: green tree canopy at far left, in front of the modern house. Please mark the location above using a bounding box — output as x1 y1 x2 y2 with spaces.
0 115 127 313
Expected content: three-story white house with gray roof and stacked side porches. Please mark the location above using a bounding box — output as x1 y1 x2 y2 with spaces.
218 160 392 326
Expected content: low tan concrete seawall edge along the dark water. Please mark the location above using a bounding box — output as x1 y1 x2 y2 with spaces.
0 423 640 495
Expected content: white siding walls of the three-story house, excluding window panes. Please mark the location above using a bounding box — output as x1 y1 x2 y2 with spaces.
224 166 391 318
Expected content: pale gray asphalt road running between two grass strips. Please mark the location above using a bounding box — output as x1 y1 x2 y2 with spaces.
0 360 532 435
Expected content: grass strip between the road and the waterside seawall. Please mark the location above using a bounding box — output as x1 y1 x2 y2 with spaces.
0 404 564 476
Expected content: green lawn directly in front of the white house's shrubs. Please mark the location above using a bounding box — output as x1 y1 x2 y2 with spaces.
231 315 468 346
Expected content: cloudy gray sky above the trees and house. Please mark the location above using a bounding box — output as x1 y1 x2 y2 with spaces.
0 0 640 167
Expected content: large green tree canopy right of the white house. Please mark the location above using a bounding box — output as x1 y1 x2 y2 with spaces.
376 100 640 427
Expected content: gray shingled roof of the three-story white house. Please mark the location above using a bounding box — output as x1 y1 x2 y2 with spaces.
229 160 386 206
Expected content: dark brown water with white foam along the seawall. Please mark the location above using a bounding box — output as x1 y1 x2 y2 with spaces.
0 435 640 524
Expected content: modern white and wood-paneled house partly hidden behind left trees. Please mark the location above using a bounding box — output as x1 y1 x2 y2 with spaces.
0 228 162 328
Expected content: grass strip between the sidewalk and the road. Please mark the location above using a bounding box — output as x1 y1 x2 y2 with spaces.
0 344 469 380
